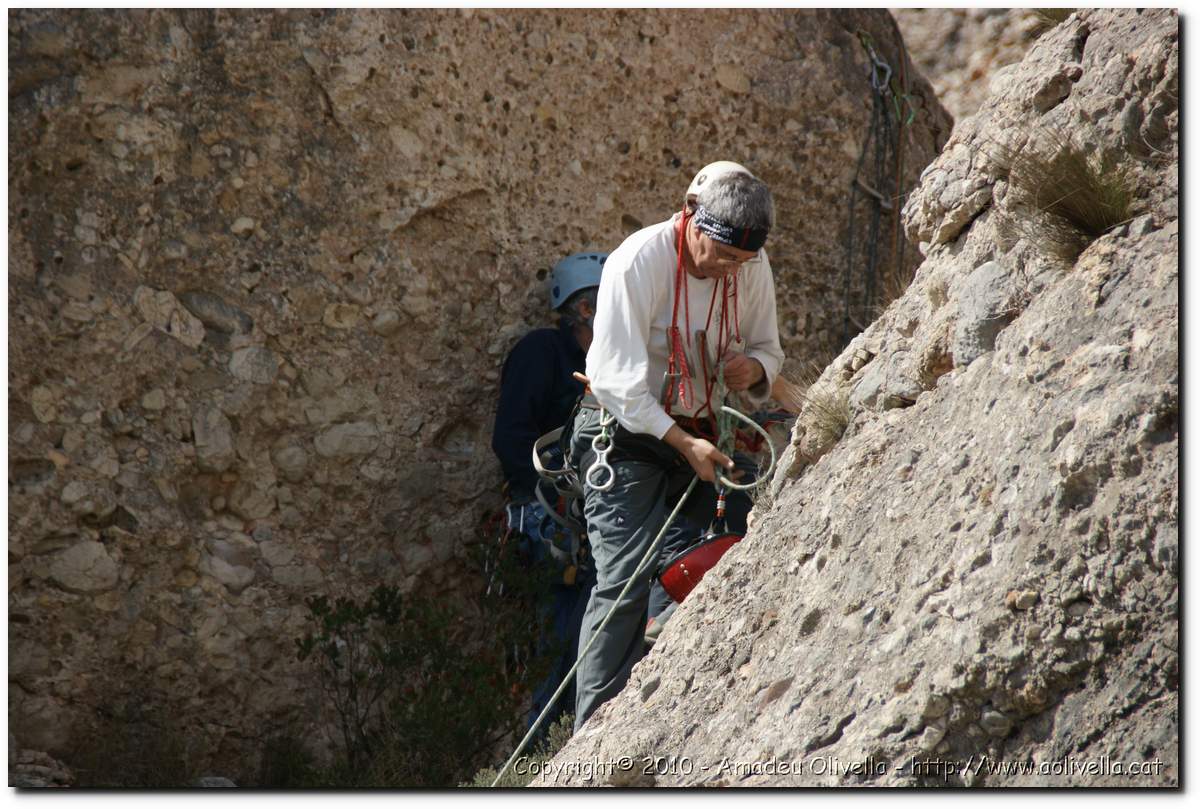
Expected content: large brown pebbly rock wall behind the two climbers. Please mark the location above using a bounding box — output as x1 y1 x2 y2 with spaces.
8 10 949 783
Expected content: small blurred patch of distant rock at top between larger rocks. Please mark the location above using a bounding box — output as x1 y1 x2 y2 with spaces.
892 8 1046 120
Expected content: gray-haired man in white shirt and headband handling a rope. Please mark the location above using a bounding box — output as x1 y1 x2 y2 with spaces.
571 162 784 727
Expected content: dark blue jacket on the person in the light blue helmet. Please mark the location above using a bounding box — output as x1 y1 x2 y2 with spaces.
492 320 587 503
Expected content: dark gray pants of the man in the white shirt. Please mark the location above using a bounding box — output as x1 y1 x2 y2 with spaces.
571 409 754 730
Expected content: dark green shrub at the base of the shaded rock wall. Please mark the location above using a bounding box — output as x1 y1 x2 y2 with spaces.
296 537 560 787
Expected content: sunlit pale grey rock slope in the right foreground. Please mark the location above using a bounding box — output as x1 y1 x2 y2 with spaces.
540 10 1180 786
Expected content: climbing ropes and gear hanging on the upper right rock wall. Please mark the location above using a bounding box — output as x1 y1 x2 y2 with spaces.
841 30 917 344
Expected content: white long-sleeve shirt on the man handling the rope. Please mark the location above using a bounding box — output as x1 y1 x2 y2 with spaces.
587 214 784 438
